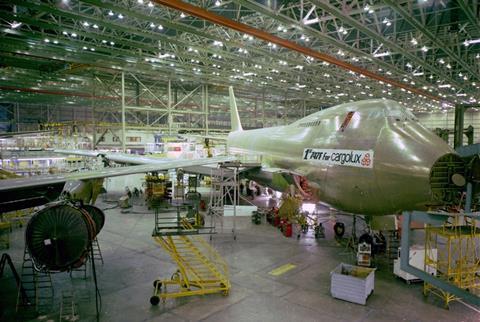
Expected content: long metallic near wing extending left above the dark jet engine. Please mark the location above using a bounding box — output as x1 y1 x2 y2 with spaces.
0 157 236 192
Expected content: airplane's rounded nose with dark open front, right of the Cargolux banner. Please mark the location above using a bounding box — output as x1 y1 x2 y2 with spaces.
374 121 465 211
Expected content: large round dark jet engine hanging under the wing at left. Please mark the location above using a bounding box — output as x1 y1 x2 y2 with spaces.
25 203 105 272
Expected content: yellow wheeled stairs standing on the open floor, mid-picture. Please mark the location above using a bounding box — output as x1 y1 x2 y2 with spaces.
150 220 231 305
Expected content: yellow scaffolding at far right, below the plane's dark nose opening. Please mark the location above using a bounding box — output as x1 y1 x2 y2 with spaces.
423 214 480 308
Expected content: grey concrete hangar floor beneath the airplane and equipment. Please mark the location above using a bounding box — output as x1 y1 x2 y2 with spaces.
0 196 480 322
